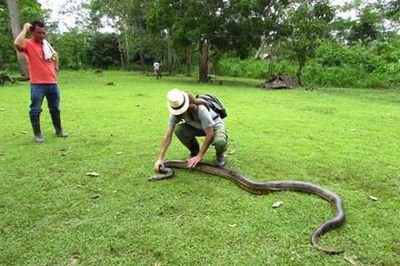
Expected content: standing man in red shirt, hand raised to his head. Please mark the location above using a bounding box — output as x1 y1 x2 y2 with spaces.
14 21 68 143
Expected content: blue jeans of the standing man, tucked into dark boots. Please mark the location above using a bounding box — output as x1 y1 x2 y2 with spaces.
29 84 60 117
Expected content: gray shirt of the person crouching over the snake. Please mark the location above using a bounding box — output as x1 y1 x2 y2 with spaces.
168 104 224 130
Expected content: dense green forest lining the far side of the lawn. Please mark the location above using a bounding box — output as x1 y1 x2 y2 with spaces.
0 0 400 88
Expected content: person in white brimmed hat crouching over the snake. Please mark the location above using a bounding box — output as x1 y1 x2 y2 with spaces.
154 89 228 171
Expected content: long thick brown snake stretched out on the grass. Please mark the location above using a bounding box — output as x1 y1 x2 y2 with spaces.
149 160 345 254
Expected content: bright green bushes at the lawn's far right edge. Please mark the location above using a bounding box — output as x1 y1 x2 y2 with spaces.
305 43 400 88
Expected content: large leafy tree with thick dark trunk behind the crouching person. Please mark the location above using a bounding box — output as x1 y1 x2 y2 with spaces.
148 0 278 82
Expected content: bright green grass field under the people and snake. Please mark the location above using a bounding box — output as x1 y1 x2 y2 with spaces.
0 71 400 265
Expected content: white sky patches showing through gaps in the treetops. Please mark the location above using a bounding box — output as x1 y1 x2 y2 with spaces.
38 0 364 32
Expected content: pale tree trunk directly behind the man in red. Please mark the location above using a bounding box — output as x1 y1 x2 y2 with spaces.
7 0 29 77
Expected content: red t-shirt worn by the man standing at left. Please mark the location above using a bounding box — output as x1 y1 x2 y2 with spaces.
21 39 57 84
